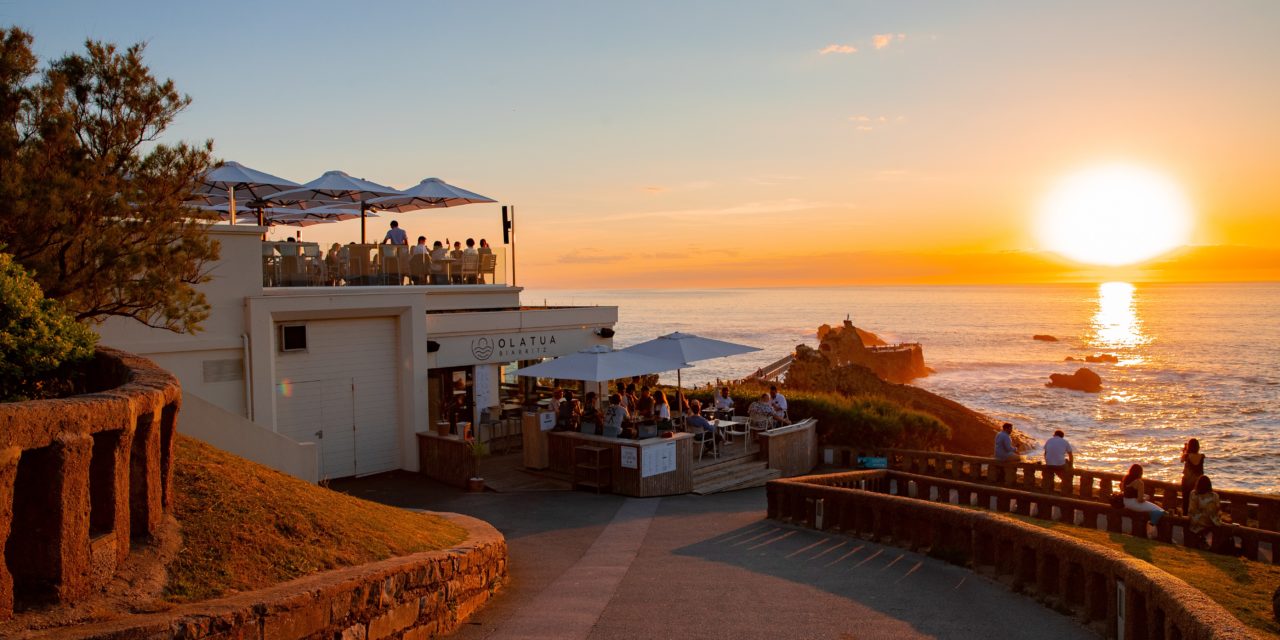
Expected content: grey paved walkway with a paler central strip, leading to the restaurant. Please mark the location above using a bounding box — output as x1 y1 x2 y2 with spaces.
335 474 1097 640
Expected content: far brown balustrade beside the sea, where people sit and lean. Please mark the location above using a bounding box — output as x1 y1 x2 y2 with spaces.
887 449 1280 531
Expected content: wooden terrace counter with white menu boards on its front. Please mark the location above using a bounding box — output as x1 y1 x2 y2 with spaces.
547 431 694 498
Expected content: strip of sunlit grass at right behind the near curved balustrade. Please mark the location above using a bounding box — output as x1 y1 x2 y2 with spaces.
1001 513 1280 637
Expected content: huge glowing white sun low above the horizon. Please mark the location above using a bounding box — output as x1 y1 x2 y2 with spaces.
1036 165 1193 266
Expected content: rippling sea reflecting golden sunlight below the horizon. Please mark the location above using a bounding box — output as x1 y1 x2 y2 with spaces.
524 283 1280 493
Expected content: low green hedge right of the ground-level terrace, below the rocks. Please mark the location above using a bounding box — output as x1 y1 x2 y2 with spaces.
687 385 951 451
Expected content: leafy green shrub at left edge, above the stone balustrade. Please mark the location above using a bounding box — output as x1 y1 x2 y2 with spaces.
0 253 97 402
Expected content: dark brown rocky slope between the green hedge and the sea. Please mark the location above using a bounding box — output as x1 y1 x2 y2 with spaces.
786 344 1034 456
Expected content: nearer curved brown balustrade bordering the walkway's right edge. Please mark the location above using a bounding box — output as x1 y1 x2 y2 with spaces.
767 471 1254 640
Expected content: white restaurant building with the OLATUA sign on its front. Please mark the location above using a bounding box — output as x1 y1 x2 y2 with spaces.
99 225 617 481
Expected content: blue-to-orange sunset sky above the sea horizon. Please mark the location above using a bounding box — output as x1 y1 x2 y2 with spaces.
10 1 1280 288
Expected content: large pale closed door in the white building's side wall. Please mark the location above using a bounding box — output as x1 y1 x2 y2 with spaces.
275 317 399 477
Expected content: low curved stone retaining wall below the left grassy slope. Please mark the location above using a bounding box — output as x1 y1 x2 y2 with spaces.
38 513 507 640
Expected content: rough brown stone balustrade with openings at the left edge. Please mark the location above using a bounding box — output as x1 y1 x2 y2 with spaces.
0 348 182 620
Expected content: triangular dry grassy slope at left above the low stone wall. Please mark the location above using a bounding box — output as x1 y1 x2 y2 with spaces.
165 435 466 602
